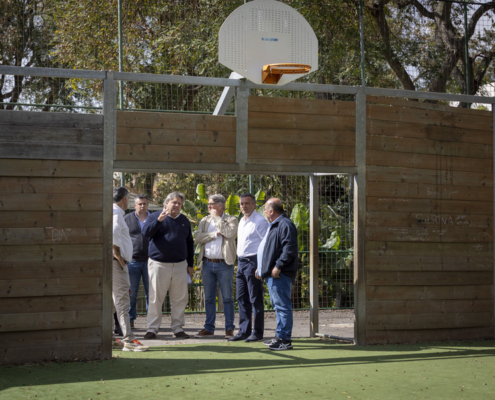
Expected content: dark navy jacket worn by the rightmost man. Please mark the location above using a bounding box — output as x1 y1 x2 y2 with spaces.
261 214 299 278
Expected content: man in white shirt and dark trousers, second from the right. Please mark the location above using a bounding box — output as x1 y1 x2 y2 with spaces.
229 193 268 342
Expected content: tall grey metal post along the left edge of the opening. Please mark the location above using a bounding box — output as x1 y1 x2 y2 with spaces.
101 72 117 358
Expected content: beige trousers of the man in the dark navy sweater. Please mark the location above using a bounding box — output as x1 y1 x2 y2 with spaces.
147 258 188 335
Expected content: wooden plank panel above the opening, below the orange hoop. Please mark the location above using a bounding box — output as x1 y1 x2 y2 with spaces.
248 96 356 167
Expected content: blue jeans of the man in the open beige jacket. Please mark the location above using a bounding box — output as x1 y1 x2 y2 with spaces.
201 259 235 332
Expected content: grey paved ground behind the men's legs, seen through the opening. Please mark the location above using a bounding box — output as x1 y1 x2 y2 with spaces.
126 310 354 346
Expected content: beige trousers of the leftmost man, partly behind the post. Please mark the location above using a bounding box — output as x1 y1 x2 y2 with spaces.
112 260 136 342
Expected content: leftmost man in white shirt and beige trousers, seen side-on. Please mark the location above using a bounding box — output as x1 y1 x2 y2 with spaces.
112 187 149 351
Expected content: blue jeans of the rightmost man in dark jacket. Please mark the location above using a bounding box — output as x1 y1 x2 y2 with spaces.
266 273 294 340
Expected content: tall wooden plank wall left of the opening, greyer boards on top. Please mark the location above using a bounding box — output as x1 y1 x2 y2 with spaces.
0 111 103 363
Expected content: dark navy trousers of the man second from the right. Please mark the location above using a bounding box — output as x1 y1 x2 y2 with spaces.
236 255 265 339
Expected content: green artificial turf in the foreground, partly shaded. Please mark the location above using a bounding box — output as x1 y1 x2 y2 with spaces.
0 339 495 400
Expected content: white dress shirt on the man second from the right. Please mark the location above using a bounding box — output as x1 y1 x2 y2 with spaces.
237 210 268 257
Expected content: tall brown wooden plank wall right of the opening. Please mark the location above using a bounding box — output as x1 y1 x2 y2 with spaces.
365 97 493 344
